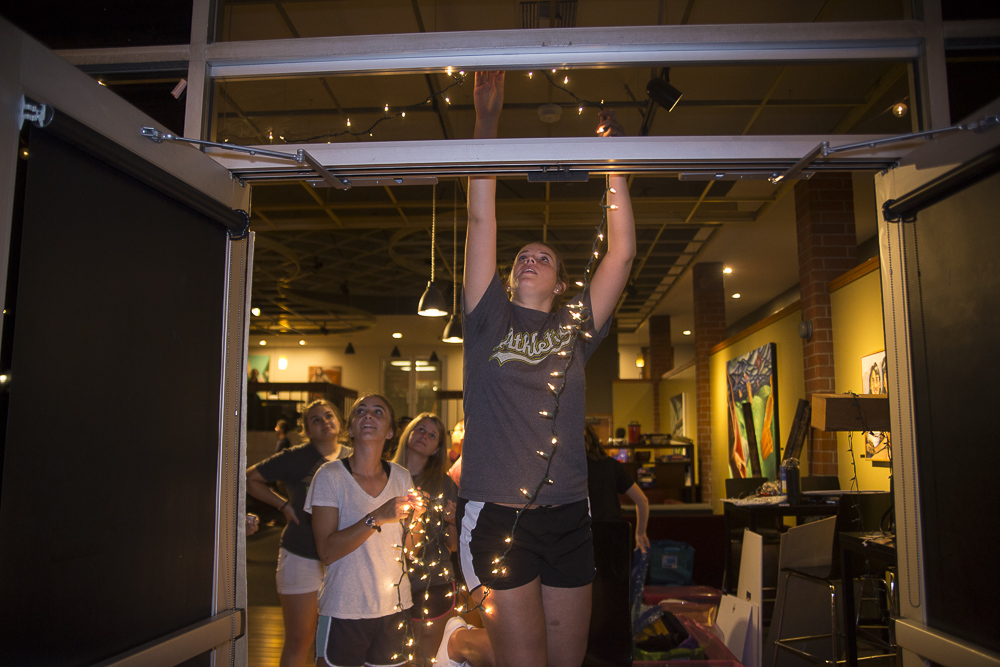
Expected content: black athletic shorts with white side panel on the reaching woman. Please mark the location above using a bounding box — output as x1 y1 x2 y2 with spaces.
458 498 595 591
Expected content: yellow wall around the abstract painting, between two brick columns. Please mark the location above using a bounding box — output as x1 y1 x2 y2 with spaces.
702 306 807 512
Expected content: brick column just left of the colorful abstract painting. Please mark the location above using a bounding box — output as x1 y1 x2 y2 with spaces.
692 262 726 498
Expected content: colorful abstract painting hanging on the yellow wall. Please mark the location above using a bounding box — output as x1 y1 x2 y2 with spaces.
726 343 780 480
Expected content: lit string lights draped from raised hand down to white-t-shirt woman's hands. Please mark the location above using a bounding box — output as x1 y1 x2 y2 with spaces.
378 178 618 661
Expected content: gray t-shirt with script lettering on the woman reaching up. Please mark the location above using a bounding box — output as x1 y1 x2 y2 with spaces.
459 274 611 505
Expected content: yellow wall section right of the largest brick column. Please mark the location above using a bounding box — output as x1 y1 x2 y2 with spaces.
830 265 891 491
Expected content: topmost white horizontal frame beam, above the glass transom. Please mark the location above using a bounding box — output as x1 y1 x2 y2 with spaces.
199 21 925 78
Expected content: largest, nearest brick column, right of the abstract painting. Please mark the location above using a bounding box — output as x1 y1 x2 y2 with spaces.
795 173 858 475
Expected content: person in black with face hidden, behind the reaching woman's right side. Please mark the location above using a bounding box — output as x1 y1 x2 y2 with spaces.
584 426 649 553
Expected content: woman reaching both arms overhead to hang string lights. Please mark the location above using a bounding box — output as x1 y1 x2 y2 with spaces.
459 72 635 667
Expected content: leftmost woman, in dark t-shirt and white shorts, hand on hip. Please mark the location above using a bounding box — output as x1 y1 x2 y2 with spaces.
247 399 351 667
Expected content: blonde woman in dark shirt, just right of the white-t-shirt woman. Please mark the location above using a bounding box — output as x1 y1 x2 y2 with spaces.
393 412 458 657
